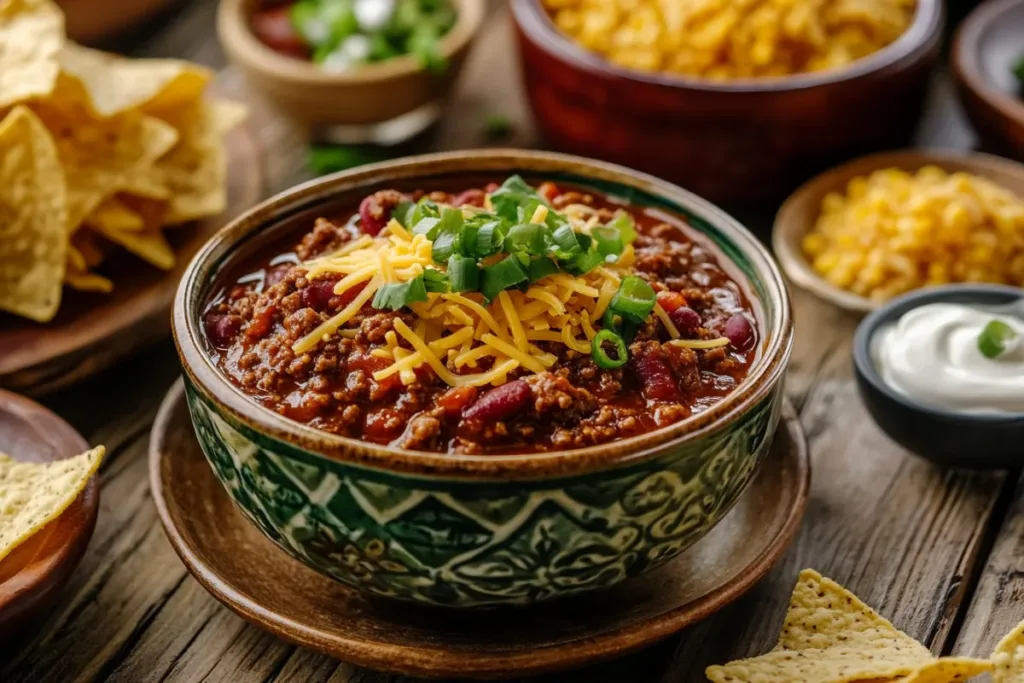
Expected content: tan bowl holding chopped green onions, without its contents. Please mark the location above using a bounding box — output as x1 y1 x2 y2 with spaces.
217 0 483 135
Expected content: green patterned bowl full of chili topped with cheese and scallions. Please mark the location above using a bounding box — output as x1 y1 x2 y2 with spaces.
174 151 792 606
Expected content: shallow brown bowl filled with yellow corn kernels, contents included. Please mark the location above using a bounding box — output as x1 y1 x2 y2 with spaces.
772 151 1024 312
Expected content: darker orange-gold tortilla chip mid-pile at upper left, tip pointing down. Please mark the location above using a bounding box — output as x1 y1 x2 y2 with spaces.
33 102 178 232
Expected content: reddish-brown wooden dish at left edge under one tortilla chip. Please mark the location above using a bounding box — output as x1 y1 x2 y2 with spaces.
0 390 99 641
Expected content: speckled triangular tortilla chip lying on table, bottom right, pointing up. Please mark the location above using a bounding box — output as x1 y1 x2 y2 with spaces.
706 569 935 683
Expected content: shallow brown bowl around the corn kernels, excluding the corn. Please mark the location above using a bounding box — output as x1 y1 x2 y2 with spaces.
772 150 1024 313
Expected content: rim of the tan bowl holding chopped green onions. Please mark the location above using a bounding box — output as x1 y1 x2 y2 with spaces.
217 0 484 86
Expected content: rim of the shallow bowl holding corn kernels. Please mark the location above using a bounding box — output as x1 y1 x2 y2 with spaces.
771 147 1024 313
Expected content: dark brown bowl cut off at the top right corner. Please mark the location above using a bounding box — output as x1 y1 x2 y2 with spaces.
952 0 1024 161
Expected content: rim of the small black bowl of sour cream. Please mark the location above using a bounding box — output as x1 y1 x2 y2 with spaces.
852 283 1024 426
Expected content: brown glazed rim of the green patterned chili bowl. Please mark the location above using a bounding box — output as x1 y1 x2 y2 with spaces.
172 150 794 480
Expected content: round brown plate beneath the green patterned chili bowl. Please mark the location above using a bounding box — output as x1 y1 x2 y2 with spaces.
150 382 810 678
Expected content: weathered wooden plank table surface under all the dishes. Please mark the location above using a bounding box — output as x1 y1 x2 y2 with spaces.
0 0 1024 683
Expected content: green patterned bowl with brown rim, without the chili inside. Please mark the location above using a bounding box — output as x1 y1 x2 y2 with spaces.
173 151 793 607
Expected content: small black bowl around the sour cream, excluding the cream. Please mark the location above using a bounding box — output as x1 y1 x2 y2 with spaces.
853 285 1024 469
